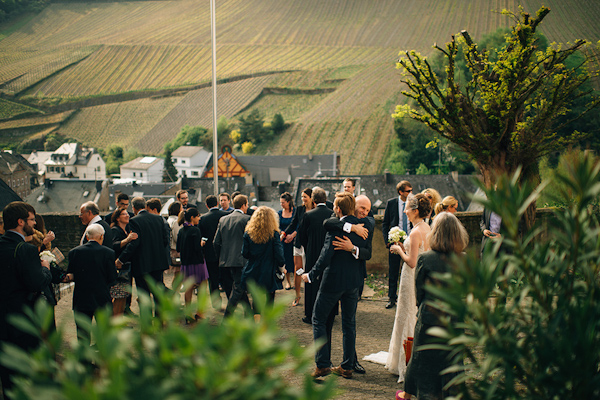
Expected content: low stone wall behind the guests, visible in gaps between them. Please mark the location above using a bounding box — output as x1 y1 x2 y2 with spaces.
43 208 552 273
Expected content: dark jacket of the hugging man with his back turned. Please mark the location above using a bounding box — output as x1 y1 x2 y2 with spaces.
308 215 367 292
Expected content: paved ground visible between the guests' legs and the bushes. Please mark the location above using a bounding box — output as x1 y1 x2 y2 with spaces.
50 275 401 400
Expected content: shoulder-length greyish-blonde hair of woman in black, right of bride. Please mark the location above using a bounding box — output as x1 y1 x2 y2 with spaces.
427 212 469 253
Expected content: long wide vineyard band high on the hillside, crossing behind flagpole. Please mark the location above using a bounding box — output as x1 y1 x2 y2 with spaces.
28 46 396 97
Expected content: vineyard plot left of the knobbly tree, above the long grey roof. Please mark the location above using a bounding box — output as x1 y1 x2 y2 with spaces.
272 64 401 174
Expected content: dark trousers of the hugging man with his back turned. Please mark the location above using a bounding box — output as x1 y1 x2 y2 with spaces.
312 288 358 370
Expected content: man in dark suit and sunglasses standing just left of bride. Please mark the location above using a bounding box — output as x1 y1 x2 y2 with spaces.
382 181 412 308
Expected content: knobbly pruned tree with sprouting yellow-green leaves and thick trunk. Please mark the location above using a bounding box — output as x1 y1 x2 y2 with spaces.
395 7 600 226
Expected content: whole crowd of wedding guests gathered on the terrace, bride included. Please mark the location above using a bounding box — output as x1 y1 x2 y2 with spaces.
0 178 492 398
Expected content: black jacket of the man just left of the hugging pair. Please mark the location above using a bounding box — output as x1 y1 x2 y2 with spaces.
298 205 333 272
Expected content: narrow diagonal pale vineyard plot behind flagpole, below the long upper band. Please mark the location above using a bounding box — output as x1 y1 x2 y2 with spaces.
134 76 272 154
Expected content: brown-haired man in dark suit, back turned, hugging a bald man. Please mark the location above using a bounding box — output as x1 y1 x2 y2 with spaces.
302 192 367 379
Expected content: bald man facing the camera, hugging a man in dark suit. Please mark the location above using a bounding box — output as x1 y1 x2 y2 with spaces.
324 195 375 374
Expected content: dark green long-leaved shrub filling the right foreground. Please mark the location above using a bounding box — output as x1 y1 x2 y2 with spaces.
430 158 600 400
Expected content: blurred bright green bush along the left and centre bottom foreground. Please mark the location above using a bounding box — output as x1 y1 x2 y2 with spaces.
0 282 333 400
